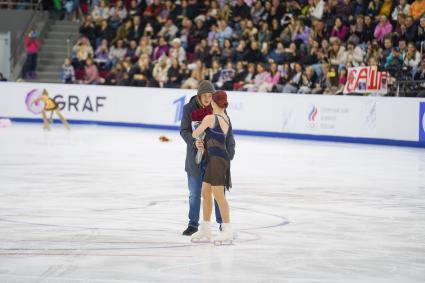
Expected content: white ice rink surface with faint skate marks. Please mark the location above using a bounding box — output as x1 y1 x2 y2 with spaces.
0 123 425 283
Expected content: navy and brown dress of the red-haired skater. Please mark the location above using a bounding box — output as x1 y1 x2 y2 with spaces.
204 114 231 189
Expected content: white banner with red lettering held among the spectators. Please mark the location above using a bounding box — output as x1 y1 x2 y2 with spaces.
344 67 388 94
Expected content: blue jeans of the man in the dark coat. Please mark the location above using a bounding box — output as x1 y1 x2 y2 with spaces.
187 161 222 228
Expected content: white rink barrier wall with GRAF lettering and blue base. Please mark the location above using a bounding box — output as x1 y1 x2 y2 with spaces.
0 83 425 147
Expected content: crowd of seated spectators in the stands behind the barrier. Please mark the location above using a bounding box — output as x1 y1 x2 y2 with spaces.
62 0 425 94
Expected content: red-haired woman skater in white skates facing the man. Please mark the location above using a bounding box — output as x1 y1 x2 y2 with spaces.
192 90 233 243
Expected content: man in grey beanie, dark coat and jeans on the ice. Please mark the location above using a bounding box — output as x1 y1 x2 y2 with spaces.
180 80 235 236
